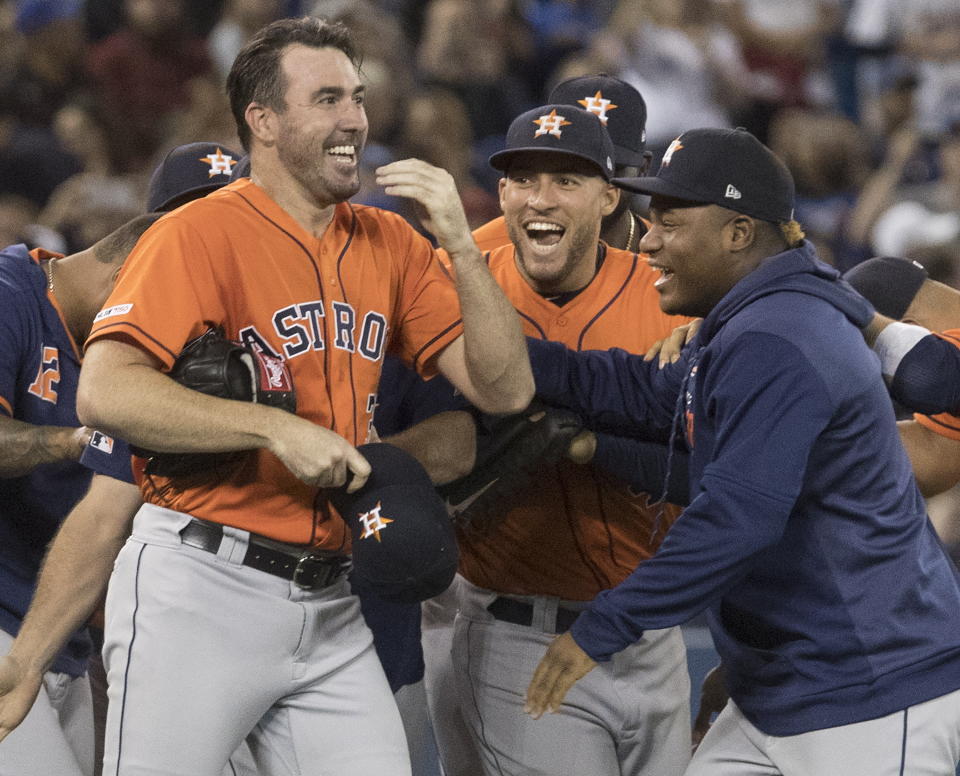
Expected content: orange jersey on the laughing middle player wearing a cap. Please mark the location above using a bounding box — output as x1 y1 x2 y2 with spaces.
460 245 689 601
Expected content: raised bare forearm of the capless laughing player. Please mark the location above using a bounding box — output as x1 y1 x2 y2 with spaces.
450 253 533 414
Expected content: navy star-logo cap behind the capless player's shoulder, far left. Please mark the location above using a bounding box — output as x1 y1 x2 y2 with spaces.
147 142 241 213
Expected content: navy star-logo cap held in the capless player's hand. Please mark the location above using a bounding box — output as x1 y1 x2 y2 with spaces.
329 442 459 603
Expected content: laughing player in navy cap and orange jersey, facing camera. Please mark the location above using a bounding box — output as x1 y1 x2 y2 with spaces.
408 104 690 775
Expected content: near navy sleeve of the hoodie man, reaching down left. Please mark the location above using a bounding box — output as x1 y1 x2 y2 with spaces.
569 333 831 660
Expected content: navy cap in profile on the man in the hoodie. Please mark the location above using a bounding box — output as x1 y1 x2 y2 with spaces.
613 129 794 223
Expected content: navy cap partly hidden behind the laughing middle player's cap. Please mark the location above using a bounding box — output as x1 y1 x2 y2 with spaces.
547 73 647 167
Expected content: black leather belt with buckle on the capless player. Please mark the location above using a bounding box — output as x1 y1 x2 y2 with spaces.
180 518 350 590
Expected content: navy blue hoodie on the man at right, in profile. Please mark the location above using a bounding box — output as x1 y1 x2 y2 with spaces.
530 243 960 735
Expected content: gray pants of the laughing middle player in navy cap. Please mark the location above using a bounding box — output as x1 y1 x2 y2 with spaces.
453 579 690 776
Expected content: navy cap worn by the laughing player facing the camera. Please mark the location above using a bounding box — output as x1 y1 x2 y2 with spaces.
490 104 614 180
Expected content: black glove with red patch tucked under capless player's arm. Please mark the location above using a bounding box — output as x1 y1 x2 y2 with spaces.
131 328 297 480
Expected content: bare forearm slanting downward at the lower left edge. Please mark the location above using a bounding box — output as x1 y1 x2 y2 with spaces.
10 475 140 674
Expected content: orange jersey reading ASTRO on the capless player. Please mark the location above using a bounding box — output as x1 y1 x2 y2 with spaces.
88 178 462 549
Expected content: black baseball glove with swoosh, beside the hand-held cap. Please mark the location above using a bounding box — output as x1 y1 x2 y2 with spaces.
437 402 583 533
